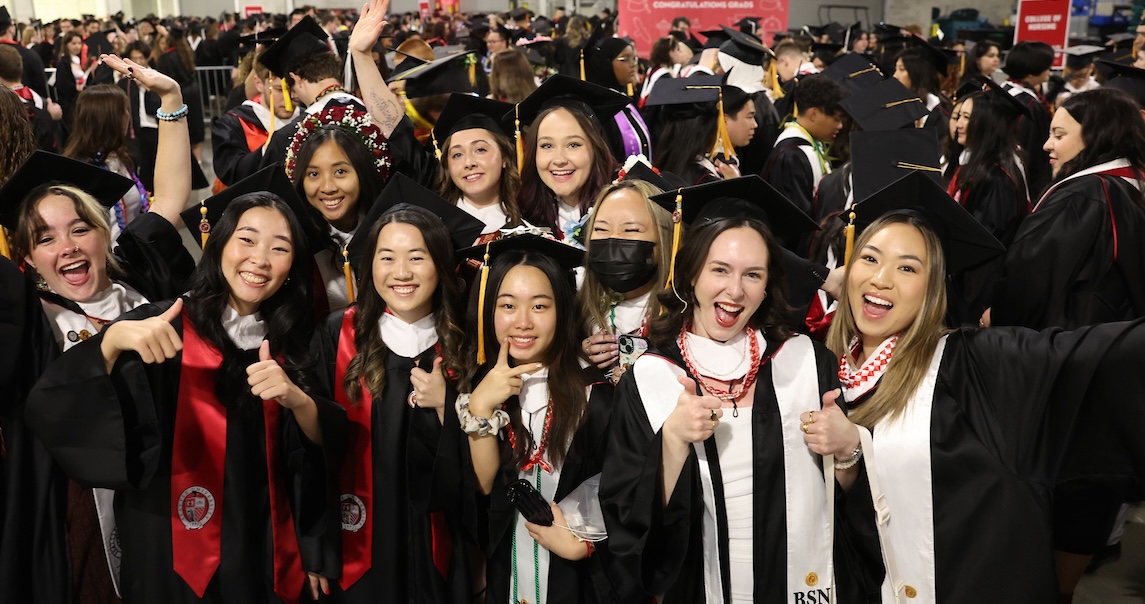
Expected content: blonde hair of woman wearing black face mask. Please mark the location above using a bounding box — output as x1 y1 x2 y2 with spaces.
577 181 672 328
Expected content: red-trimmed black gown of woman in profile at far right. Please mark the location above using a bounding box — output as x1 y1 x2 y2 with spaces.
990 169 1145 329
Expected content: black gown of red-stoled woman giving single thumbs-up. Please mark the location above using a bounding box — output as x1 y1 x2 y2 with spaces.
314 311 473 604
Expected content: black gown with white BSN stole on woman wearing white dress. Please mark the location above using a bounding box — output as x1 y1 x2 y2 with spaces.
600 334 854 604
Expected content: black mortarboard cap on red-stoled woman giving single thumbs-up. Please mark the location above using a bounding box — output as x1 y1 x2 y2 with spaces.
346 172 485 267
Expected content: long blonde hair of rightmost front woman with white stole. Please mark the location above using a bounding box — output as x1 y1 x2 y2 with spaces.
827 214 948 429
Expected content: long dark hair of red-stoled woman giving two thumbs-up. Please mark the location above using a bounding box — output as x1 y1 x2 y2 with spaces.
185 192 314 408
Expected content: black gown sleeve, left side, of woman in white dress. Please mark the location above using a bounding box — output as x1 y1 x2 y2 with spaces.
600 363 704 594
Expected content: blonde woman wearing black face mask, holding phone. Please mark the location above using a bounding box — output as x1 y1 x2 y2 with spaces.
578 176 672 382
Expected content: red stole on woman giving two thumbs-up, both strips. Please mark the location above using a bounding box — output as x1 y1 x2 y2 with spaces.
171 310 306 603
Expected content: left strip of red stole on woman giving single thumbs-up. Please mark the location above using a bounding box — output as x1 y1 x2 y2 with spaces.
333 307 373 590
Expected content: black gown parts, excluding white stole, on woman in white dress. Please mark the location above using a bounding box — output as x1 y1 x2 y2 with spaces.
600 342 856 604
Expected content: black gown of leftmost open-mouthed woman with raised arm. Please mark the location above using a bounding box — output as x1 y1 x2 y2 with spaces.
0 214 195 604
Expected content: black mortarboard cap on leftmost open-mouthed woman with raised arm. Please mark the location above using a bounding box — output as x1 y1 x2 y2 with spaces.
0 151 135 231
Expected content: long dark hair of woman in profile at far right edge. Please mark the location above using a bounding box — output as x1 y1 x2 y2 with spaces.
1057 88 1145 181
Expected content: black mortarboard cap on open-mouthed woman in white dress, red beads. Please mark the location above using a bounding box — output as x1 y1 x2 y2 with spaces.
652 175 819 237
